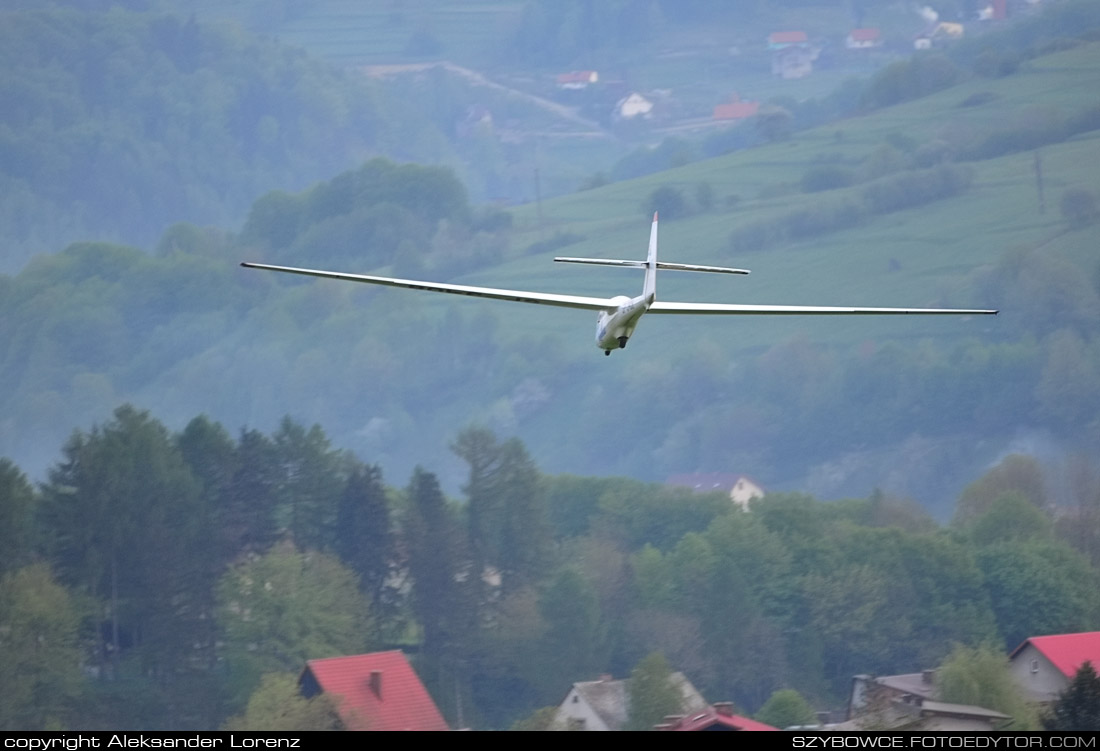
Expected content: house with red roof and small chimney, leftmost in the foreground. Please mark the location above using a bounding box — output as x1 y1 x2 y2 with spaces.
298 650 450 730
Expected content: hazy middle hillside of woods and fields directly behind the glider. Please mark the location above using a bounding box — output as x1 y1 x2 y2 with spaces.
0 25 1100 510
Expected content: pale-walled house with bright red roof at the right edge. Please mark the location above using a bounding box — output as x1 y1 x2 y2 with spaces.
1009 631 1100 703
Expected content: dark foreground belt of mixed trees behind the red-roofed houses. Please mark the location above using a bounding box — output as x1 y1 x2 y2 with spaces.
0 406 1100 730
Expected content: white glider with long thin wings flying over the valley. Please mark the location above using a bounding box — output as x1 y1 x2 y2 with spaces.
241 213 997 355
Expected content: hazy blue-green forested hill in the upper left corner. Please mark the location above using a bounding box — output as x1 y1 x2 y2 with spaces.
0 9 451 272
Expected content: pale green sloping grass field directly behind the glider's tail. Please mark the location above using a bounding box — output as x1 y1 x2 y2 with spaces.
400 44 1100 356
